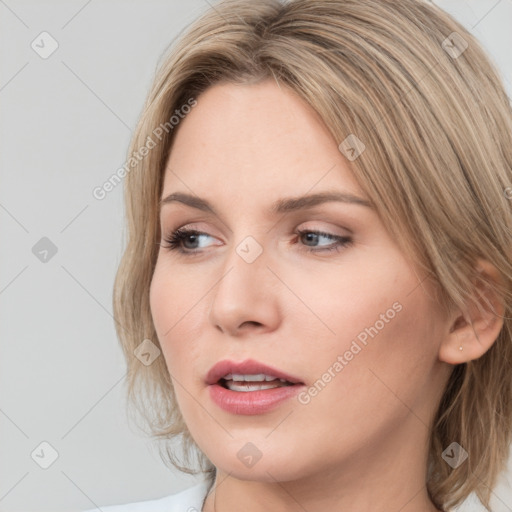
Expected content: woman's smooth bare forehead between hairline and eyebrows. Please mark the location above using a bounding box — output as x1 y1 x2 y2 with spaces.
163 80 362 203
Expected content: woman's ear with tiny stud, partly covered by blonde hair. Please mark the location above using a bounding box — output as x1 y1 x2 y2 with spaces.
439 260 505 364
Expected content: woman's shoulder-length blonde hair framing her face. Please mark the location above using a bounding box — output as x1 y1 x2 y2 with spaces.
113 0 512 510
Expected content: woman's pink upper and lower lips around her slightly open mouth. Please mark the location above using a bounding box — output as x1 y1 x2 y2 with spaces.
206 359 304 415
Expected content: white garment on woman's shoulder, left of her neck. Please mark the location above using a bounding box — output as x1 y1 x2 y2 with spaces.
85 480 209 512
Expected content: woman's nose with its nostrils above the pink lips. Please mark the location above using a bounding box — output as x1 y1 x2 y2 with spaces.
209 238 282 337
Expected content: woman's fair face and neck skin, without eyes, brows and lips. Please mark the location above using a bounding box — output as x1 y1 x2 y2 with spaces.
150 81 500 512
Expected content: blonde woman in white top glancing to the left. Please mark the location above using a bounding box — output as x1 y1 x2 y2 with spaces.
87 0 512 512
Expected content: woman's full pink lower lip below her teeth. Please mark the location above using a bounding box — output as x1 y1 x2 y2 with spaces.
209 384 304 415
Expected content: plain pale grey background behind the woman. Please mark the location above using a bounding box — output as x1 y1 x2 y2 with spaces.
0 0 512 512
